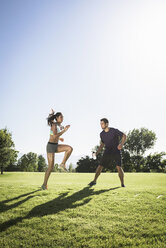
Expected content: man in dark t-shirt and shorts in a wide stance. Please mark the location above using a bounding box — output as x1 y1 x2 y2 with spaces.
88 118 126 187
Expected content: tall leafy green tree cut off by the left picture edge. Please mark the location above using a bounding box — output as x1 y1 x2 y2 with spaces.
0 128 18 174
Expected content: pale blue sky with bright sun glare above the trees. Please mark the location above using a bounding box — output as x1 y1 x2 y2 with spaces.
0 0 166 165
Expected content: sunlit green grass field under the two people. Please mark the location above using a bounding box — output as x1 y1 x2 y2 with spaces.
0 172 166 248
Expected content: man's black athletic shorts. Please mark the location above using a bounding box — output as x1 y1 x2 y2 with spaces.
100 152 122 168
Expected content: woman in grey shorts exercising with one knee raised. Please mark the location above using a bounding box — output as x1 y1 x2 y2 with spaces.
41 110 73 190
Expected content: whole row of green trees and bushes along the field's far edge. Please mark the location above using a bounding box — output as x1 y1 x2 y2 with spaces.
0 128 166 174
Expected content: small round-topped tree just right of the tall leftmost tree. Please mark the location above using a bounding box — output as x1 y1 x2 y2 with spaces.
18 152 38 171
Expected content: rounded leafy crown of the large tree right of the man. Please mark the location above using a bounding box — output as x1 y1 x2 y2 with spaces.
125 128 157 156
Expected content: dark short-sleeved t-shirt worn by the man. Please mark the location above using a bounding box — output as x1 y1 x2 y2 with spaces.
100 127 123 153
